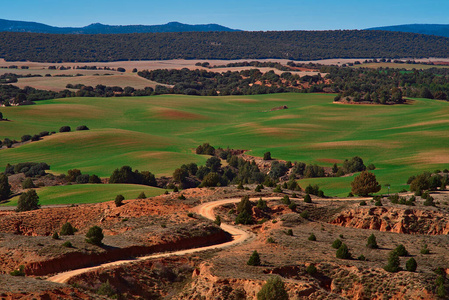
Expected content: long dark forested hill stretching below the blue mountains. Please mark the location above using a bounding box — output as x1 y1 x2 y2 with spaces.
0 30 449 62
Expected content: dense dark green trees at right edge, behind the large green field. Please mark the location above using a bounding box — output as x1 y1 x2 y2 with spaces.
321 66 449 104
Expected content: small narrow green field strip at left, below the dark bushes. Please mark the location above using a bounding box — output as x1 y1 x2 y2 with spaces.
0 184 165 206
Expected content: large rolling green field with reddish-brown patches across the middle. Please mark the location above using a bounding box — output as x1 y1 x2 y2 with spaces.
0 94 449 195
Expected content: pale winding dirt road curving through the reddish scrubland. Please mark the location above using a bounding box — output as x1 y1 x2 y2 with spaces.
47 197 256 283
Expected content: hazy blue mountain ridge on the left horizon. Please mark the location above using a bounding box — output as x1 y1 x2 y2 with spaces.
0 19 240 34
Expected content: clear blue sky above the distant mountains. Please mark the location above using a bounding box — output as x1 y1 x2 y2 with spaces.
0 0 449 30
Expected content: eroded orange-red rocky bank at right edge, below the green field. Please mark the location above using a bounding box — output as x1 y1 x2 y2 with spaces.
330 207 449 235
